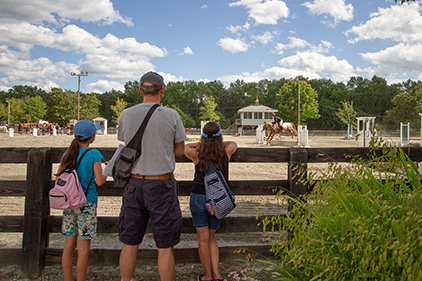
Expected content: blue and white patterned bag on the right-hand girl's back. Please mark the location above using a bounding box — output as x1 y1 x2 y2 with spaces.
204 163 236 220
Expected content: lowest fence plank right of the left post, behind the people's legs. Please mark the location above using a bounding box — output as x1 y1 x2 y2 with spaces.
45 245 274 266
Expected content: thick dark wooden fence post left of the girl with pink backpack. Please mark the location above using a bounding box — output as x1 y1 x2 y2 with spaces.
21 148 52 278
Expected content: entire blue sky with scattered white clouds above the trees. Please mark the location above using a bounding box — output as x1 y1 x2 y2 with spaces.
0 0 422 93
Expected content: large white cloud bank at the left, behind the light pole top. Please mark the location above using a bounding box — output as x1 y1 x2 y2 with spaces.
0 23 167 88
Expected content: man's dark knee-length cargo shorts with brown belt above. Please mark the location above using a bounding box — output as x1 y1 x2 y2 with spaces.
117 177 182 249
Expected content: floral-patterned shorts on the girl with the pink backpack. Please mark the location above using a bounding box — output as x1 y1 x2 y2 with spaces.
62 203 97 239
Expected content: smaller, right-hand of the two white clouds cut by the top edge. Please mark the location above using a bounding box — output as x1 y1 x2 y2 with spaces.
302 0 354 25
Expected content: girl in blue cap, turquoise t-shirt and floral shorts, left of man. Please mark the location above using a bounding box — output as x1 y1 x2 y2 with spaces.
56 120 107 281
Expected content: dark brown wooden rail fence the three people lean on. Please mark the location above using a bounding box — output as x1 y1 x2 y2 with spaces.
0 145 422 278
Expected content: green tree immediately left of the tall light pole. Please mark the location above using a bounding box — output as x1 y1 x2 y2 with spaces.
47 88 78 125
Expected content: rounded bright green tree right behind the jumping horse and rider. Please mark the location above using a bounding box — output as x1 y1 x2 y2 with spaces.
275 81 320 124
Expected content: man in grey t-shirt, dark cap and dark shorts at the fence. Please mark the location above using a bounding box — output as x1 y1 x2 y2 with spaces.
117 72 186 281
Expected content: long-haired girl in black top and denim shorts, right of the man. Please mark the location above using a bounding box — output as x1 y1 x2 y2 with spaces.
184 122 237 281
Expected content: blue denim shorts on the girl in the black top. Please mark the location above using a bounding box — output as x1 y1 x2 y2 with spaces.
189 193 221 230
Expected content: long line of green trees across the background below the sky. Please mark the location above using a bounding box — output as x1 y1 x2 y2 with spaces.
0 76 422 130
